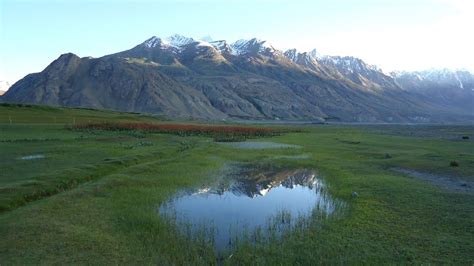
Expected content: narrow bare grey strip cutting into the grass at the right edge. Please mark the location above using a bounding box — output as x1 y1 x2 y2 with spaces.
390 167 474 194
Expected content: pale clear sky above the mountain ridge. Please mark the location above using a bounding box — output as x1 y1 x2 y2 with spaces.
0 0 474 82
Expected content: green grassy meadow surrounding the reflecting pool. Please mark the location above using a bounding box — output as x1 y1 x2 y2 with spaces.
0 105 474 265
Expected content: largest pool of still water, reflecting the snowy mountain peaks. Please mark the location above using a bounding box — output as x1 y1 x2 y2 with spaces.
159 169 344 252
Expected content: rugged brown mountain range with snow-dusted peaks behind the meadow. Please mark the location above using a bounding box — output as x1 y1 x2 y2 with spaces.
0 35 474 123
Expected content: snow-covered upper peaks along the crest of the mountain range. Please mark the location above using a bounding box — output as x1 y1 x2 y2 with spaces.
143 34 474 90
